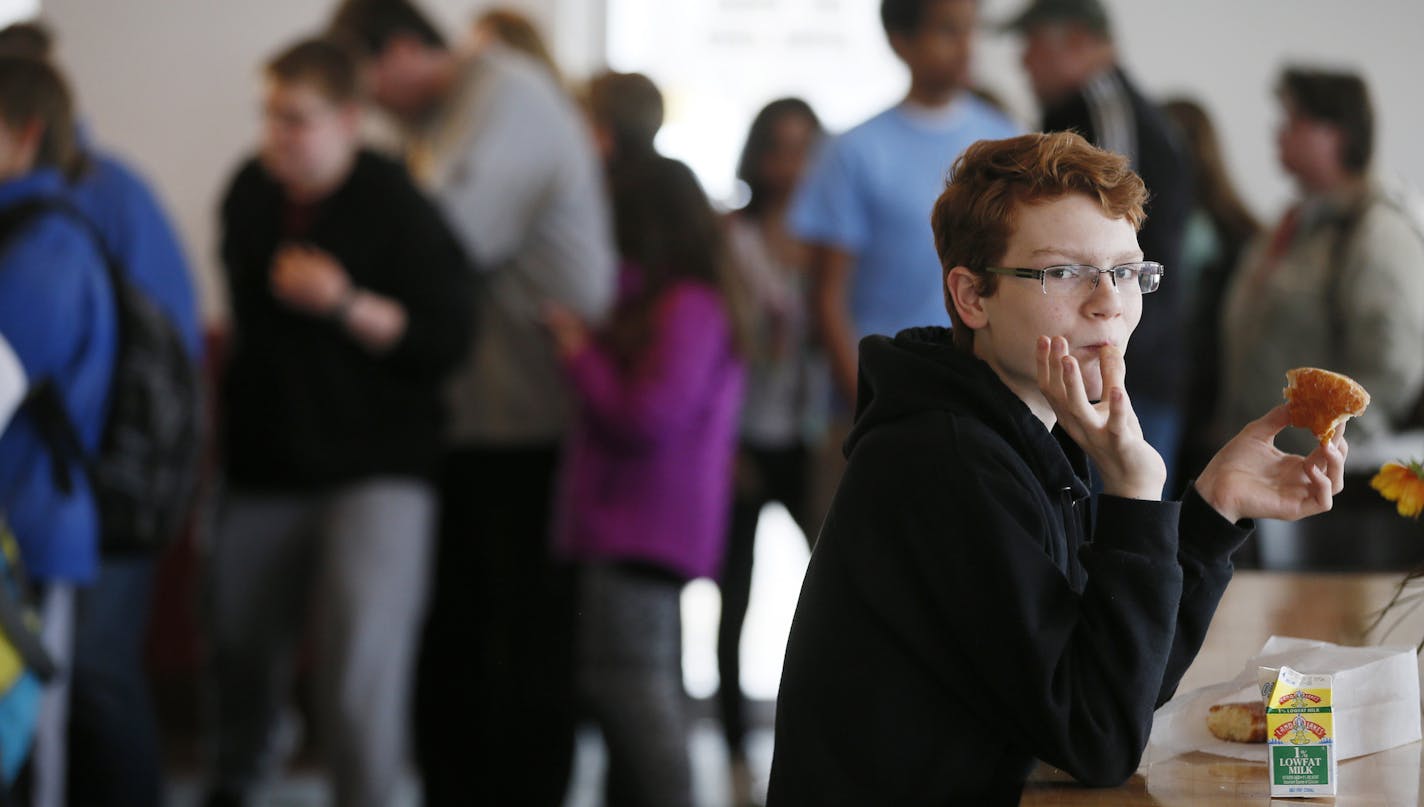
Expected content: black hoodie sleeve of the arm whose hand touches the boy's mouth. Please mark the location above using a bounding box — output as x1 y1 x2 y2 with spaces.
831 418 1183 786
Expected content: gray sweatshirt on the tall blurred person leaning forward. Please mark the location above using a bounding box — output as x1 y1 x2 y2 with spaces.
412 47 617 447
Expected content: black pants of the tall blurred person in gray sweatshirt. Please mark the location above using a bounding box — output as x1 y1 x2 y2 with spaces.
414 447 575 807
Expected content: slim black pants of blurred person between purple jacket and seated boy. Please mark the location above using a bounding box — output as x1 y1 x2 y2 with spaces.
716 444 815 756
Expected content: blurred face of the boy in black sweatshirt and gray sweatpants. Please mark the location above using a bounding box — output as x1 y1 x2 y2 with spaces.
262 80 360 188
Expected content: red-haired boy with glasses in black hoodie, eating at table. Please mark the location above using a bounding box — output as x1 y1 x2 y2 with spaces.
768 132 1346 807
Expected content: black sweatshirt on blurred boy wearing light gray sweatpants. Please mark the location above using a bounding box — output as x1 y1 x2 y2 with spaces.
222 149 472 491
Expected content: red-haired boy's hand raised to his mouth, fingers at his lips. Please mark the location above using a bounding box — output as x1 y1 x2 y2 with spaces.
1037 336 1166 501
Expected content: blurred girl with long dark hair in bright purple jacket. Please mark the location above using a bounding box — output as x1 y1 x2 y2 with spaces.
548 74 743 807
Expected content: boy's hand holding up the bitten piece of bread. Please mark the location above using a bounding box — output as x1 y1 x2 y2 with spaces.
1196 403 1350 521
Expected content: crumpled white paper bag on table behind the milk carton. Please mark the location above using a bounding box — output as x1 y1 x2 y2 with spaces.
1142 636 1420 764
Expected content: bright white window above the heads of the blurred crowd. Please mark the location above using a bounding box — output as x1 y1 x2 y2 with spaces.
608 0 906 205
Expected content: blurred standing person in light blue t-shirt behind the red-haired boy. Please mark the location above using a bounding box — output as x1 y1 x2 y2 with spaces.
790 0 1021 529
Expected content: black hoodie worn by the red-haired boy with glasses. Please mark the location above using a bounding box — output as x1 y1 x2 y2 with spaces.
768 329 1249 807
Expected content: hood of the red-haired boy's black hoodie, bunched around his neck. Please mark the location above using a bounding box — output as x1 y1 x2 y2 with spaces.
844 327 1089 500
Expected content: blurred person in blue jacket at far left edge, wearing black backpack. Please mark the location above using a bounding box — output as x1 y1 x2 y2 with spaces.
0 57 117 806
